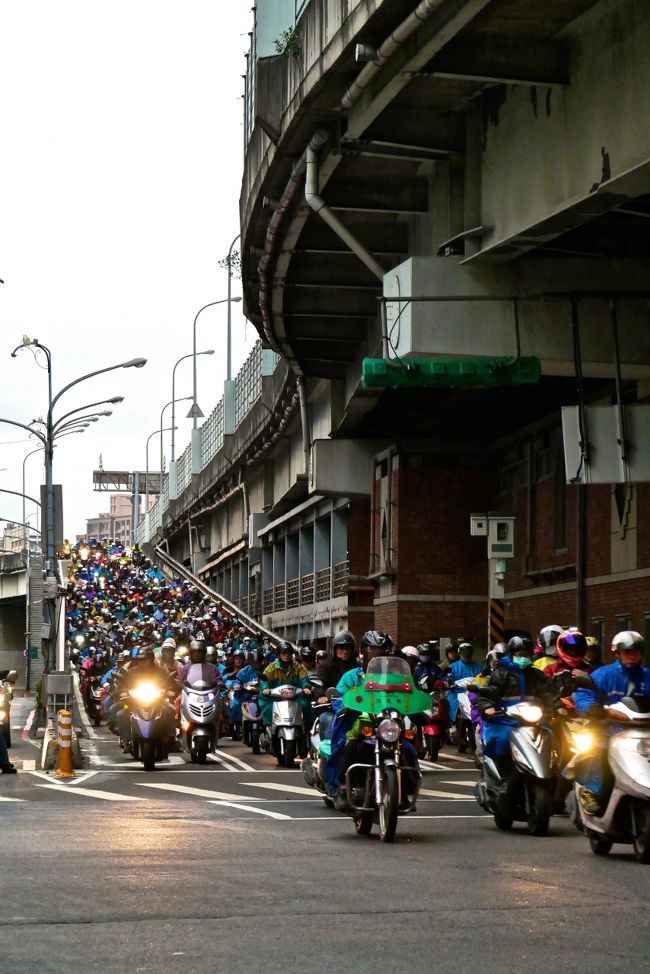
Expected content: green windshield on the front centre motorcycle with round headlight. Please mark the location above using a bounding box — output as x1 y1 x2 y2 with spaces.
343 656 431 714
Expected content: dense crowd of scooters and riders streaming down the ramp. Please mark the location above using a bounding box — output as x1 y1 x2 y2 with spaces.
63 542 650 862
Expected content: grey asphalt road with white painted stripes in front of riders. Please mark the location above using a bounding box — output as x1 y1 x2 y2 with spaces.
0 708 650 974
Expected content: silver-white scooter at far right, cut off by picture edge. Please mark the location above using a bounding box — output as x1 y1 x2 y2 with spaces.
567 694 650 864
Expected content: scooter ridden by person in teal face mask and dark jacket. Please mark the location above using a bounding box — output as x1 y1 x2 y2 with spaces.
475 701 560 835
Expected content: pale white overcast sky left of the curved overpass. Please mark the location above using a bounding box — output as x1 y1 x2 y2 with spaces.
0 0 257 538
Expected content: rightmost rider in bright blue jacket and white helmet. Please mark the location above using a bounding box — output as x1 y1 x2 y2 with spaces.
573 629 650 815
